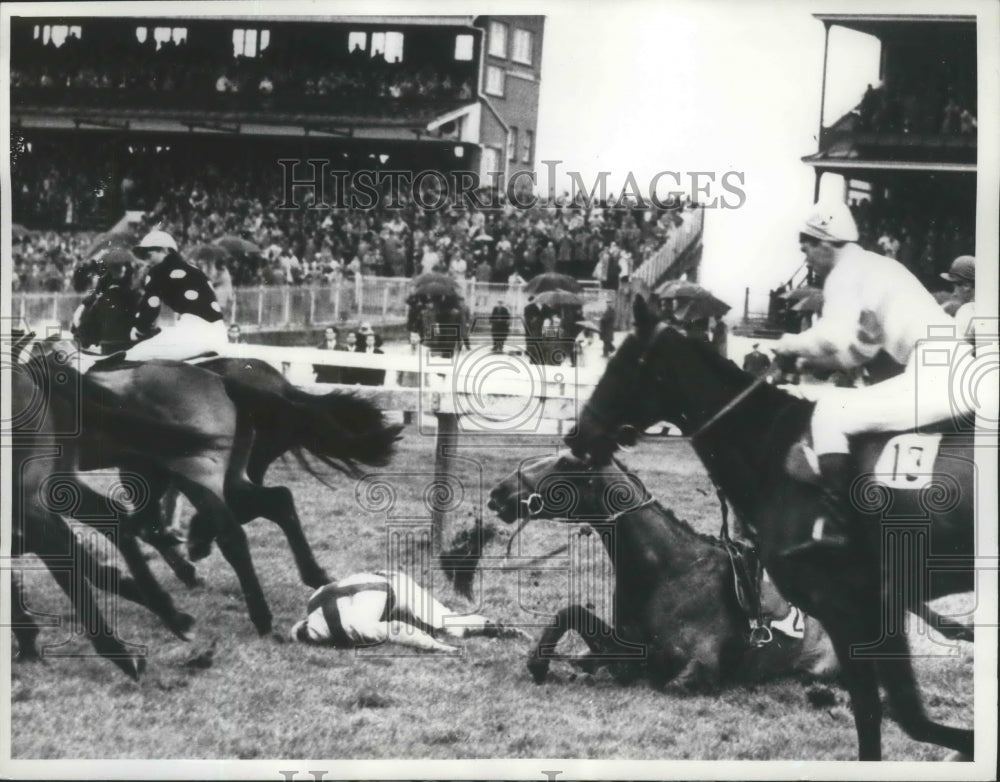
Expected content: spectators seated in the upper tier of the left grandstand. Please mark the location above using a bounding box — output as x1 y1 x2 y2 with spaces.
10 32 473 109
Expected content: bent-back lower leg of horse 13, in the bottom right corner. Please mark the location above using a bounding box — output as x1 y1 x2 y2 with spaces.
875 635 975 758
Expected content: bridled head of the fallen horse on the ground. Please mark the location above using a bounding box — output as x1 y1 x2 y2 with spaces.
488 454 649 524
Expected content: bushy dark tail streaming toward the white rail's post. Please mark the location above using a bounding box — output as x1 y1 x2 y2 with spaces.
222 376 402 473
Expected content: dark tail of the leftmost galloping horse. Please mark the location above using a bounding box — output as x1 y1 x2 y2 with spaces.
43 367 219 458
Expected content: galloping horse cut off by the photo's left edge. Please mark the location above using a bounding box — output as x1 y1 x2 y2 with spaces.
10 346 221 678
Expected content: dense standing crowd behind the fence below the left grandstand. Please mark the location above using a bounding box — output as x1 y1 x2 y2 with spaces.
13 139 704 296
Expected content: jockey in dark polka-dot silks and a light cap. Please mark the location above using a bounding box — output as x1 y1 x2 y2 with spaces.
125 231 228 361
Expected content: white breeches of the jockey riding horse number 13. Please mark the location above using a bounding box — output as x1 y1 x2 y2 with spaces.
812 341 997 454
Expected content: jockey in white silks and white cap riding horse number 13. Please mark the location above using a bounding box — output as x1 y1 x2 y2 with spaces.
774 203 975 497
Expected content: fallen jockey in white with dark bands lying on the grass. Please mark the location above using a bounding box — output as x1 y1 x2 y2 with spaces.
289 571 500 652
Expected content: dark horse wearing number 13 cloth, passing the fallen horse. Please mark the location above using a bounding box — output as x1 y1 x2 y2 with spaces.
566 297 974 760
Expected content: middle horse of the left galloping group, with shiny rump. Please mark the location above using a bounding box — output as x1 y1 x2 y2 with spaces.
34 343 398 635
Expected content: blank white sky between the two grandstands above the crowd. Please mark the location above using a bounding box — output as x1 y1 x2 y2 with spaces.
537 1 879 316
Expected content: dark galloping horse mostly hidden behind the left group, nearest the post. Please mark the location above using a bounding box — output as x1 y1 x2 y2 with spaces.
150 358 403 587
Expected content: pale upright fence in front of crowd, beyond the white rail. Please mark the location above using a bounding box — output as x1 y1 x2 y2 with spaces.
11 276 607 331
